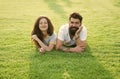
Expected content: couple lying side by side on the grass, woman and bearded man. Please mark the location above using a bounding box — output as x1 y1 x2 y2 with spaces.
31 12 87 53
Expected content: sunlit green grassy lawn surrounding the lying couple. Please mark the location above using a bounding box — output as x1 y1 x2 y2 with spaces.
0 0 120 79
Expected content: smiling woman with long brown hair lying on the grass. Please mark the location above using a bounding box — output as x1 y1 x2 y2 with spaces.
31 16 57 53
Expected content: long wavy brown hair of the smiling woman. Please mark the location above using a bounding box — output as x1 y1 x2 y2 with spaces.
31 16 54 47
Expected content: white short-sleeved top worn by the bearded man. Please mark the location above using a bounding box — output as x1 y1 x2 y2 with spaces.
58 24 87 46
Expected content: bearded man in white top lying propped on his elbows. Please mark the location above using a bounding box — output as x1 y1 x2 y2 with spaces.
56 13 87 53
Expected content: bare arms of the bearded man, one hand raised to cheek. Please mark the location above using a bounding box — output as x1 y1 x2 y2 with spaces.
56 27 86 52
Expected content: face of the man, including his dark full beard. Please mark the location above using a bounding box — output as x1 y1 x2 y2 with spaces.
69 18 81 36
